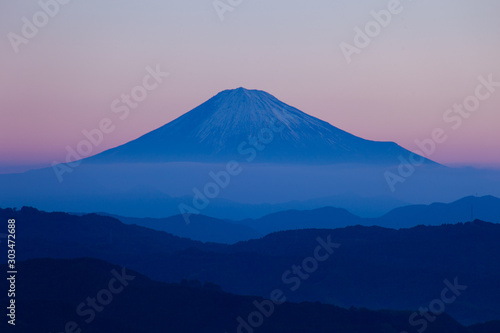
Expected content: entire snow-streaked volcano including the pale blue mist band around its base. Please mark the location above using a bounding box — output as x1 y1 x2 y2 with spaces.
0 88 500 219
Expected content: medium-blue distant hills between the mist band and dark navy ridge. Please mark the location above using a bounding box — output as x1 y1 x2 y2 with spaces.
110 196 500 243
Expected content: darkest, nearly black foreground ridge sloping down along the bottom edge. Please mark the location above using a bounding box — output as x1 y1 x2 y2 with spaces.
0 259 492 333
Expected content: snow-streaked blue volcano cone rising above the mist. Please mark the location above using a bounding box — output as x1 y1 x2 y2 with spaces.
87 88 433 165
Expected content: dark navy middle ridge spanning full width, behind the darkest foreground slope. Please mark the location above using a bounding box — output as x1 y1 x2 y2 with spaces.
0 208 500 324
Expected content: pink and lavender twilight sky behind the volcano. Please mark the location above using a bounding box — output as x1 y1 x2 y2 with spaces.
0 0 500 172
